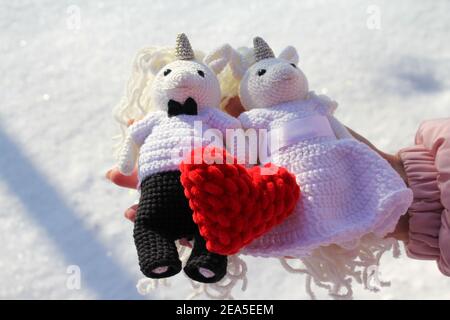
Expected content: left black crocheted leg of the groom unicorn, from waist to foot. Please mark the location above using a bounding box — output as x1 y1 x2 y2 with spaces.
134 171 196 278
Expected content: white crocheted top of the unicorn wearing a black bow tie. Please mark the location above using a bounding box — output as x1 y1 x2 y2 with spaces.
129 107 241 183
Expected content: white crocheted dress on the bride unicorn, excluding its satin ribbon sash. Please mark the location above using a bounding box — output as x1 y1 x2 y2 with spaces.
239 95 412 257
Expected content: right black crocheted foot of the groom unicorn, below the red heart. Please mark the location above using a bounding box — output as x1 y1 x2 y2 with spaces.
184 229 227 283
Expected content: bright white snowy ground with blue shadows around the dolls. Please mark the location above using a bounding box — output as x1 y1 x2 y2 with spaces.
0 0 450 299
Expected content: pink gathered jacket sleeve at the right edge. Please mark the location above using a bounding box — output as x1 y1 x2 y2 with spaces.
400 118 450 276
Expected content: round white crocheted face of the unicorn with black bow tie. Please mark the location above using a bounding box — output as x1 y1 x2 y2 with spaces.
152 60 220 111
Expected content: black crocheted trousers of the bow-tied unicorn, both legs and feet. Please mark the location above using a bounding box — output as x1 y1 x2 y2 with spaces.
134 171 227 283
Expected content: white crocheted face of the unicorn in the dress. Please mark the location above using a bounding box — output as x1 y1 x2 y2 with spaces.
239 58 308 110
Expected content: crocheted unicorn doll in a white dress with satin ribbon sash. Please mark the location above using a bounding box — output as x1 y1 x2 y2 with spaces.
231 37 412 257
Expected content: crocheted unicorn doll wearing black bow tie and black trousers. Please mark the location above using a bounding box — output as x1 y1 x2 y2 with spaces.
118 34 240 283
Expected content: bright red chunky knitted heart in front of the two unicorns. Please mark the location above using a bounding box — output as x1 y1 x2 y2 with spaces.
180 148 300 255
